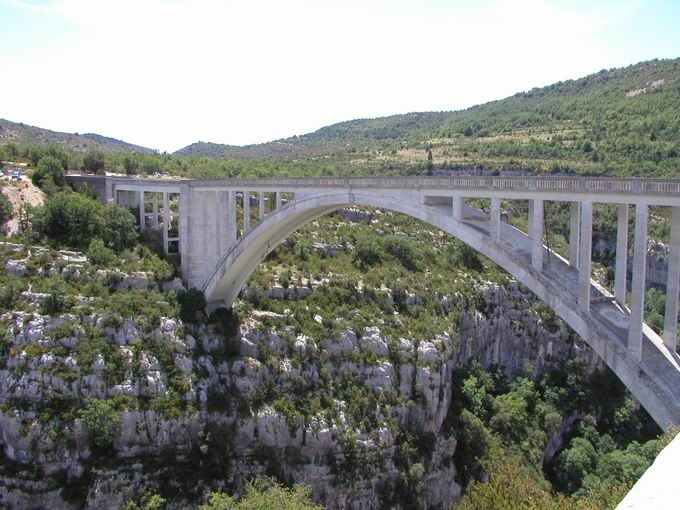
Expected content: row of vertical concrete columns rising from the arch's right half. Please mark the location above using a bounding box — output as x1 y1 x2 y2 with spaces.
444 196 680 360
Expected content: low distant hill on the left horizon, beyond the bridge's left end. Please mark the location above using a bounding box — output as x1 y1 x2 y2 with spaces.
0 119 156 153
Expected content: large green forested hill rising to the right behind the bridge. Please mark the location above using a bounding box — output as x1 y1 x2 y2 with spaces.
178 59 680 176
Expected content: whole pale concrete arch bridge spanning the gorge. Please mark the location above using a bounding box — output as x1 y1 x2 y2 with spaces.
68 176 680 429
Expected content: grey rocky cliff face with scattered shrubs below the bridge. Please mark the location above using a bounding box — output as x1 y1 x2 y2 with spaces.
0 264 597 509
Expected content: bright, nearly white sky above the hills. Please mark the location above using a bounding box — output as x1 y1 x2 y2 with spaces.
0 0 680 152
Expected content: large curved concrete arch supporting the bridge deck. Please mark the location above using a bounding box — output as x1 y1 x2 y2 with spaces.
203 191 680 430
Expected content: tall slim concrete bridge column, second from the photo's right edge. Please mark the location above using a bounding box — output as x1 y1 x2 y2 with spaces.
628 204 647 360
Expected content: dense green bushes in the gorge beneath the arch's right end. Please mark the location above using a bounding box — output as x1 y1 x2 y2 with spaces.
451 360 670 509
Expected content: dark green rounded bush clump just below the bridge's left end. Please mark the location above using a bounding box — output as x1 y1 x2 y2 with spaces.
32 191 138 250
